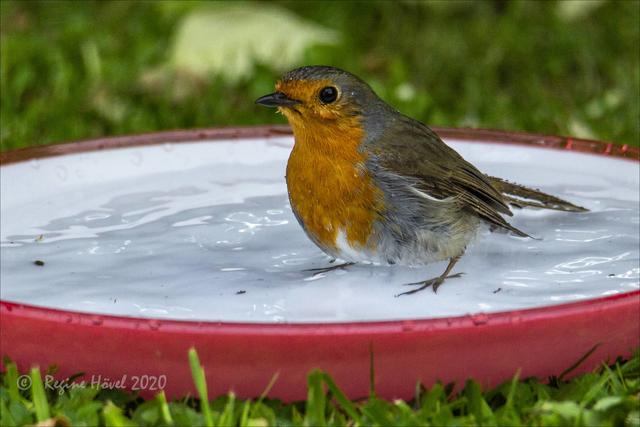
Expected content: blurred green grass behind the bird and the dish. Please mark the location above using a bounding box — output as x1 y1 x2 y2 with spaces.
0 0 640 150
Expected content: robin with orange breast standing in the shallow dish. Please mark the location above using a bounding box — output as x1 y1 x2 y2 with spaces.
255 65 587 296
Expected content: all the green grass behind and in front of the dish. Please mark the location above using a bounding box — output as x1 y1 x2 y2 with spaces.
0 0 640 426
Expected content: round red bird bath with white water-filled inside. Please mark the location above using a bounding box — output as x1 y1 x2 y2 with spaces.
0 126 640 399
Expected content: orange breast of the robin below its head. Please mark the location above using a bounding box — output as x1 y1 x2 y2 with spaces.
287 115 384 250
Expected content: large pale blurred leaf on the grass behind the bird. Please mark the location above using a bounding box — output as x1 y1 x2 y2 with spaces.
170 3 338 81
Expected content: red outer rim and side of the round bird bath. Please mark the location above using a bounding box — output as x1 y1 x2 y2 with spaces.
0 126 640 401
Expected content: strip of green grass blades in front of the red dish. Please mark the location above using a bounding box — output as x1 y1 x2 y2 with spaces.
0 349 640 427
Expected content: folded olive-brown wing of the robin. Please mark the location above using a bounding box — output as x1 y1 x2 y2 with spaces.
370 117 530 237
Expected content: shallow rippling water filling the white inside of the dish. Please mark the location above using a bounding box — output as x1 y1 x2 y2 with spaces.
0 138 640 322
